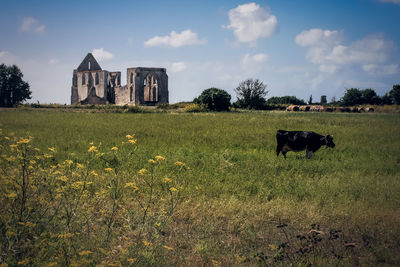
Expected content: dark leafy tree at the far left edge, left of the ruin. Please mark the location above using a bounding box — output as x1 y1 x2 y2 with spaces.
0 64 32 107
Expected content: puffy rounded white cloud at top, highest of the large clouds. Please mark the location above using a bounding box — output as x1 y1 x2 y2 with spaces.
223 3 278 45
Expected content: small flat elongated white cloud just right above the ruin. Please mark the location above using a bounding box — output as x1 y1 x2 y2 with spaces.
144 29 207 48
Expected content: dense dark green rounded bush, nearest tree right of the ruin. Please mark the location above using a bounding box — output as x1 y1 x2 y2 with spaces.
193 88 231 111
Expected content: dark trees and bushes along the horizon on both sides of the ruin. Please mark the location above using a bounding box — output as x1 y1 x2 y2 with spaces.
0 64 400 111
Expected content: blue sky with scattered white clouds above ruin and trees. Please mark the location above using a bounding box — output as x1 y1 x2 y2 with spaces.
0 0 400 104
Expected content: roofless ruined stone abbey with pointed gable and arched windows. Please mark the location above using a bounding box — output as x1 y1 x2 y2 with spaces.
71 53 168 106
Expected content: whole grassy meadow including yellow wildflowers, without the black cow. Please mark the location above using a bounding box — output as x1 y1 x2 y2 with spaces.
0 110 400 267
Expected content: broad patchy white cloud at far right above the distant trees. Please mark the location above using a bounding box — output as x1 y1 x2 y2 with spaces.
295 29 395 74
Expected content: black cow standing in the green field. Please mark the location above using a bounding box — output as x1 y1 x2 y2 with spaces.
276 130 335 159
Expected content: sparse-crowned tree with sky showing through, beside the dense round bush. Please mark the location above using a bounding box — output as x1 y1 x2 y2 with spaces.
235 79 268 109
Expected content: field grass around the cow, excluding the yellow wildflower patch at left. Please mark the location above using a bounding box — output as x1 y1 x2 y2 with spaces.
0 110 400 265
